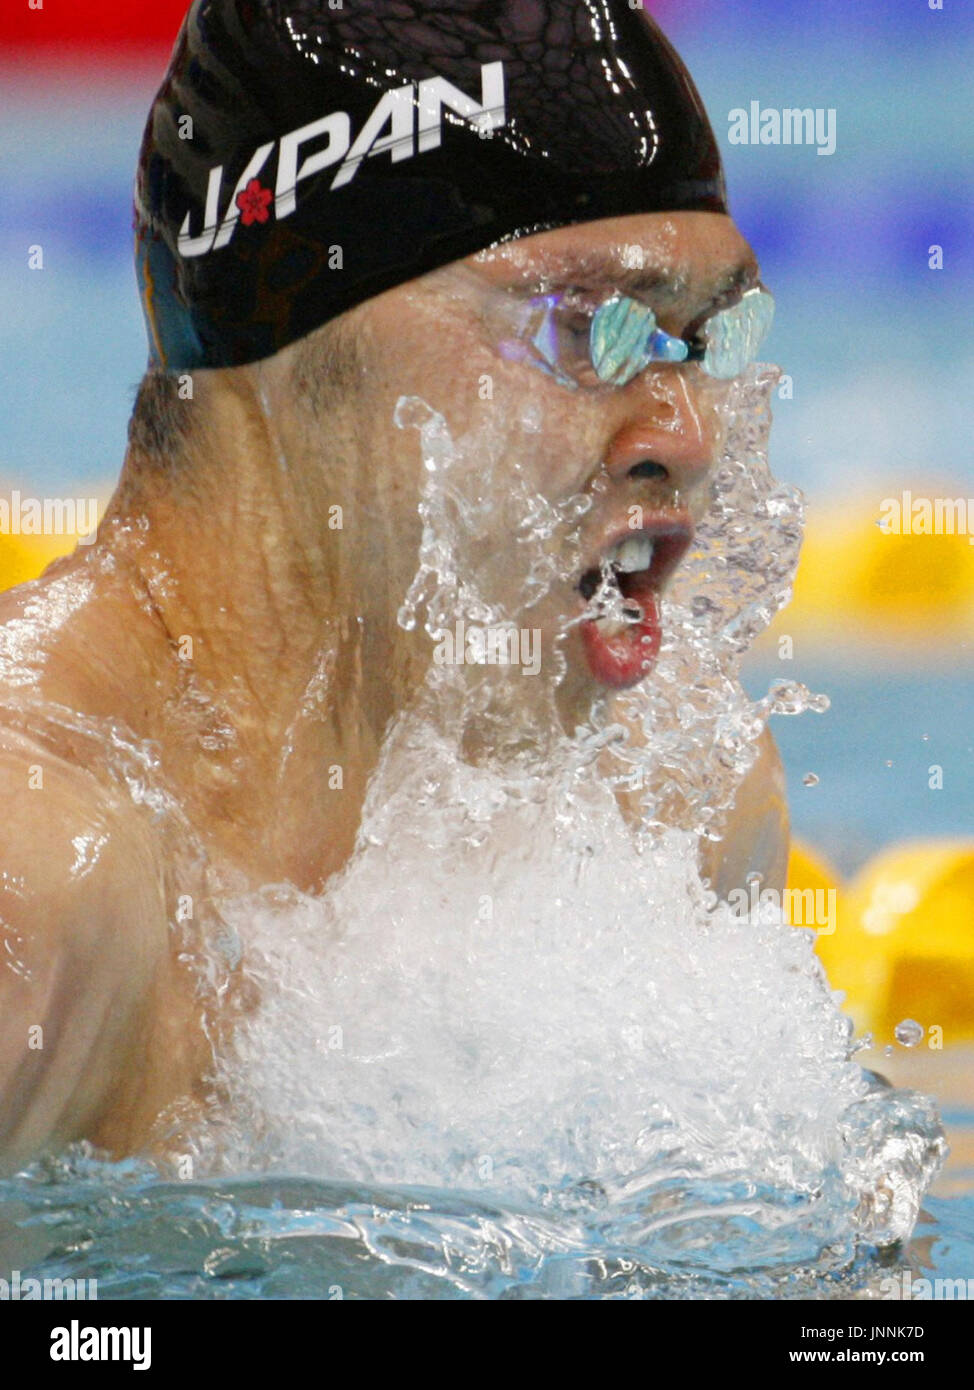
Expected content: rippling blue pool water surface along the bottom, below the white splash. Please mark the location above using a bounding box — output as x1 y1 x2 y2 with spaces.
0 1128 974 1300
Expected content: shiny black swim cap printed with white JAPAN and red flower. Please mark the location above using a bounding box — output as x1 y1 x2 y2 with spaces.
135 0 727 371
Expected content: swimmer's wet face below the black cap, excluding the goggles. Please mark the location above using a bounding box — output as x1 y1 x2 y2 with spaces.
272 213 759 719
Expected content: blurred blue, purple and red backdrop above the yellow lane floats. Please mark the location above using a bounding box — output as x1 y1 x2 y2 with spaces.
0 0 974 505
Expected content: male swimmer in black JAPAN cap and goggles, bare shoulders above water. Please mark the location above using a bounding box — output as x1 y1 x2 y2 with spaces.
0 0 788 1166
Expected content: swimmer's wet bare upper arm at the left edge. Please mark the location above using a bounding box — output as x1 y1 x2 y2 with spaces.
0 745 167 1169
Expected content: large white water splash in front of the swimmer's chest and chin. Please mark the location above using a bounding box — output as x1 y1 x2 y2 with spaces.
159 373 943 1291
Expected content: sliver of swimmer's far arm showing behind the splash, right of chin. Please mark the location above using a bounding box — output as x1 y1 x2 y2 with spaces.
700 728 791 899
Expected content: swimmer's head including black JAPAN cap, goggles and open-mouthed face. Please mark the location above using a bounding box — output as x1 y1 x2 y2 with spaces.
118 0 770 728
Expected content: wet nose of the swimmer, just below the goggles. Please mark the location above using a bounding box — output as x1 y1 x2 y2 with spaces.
606 373 718 492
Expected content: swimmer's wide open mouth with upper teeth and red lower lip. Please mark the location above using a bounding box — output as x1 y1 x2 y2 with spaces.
578 513 693 689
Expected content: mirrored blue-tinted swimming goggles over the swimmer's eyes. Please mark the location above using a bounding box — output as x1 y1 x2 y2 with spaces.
496 288 774 388
